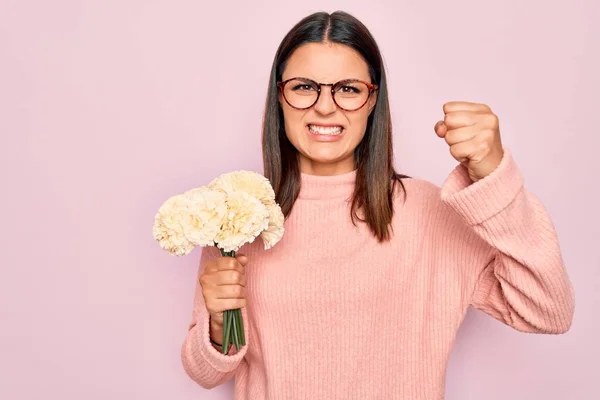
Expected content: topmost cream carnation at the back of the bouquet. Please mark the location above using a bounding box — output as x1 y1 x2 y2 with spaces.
208 171 275 205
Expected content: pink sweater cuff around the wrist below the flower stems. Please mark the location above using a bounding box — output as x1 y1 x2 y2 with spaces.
196 307 248 372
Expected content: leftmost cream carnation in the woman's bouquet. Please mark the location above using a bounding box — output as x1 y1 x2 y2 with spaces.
152 195 195 256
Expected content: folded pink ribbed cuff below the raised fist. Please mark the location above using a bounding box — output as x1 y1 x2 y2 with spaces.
441 149 523 225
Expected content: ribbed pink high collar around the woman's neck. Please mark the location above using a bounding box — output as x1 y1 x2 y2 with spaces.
298 169 357 200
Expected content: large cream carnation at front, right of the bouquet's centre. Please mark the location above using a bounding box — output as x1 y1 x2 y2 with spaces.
215 191 269 252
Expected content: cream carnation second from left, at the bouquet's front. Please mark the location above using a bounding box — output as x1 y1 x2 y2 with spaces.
184 186 227 246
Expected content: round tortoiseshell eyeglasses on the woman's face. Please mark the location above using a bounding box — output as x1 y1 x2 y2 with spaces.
277 78 377 111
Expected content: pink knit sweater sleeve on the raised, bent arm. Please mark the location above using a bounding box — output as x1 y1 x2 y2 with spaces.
441 149 575 334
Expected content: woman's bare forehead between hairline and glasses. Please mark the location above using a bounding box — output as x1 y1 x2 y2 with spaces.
283 43 370 83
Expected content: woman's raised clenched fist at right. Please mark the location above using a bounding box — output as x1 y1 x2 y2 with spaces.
434 101 504 182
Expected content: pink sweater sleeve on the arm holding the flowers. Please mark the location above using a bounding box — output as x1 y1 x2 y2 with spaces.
181 247 249 389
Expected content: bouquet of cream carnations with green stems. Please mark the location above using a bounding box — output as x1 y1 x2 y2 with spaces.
152 171 284 354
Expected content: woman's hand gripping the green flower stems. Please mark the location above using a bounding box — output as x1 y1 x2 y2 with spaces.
199 254 248 334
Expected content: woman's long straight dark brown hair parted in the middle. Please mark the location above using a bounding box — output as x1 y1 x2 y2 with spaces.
262 11 406 242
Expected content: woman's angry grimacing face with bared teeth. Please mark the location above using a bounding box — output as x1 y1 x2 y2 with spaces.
279 43 376 175
